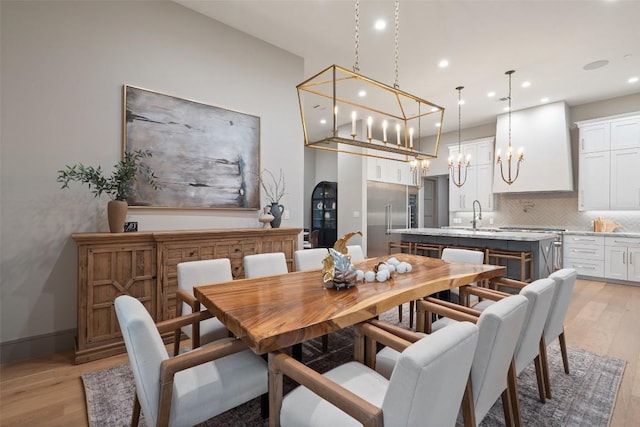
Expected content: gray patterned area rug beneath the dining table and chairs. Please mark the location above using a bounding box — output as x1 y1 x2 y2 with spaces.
82 304 625 427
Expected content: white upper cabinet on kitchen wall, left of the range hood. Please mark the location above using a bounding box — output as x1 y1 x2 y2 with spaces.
449 137 494 212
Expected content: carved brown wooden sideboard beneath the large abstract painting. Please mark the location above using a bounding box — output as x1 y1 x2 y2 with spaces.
71 228 302 363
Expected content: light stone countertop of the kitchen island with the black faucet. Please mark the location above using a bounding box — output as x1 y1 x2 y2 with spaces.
390 228 556 242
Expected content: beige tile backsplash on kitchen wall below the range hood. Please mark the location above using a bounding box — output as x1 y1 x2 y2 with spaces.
450 192 640 233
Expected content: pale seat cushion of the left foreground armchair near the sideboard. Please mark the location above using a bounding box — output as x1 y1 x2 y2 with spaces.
169 344 268 426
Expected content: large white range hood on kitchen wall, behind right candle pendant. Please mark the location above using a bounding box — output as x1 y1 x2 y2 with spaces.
493 101 573 193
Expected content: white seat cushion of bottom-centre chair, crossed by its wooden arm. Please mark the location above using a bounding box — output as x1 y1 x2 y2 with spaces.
280 362 389 427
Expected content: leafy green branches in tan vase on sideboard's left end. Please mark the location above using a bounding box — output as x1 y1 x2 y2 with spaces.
57 150 160 233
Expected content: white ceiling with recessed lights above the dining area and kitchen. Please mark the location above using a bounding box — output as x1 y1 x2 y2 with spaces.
174 0 640 132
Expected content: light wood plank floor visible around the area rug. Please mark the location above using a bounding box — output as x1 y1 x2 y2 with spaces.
0 280 640 427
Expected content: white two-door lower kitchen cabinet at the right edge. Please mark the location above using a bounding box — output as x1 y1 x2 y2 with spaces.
604 237 640 282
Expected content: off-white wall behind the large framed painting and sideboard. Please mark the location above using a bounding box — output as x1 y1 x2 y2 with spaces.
0 1 304 362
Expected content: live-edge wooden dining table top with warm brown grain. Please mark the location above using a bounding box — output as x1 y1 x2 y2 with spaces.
194 254 506 354
